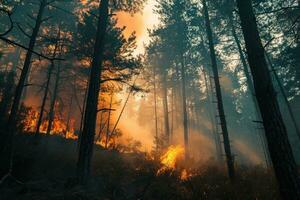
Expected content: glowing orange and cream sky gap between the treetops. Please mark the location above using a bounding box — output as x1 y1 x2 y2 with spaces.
117 0 159 53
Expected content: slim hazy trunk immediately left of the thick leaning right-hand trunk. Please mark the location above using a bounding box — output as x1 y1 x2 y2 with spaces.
228 14 269 166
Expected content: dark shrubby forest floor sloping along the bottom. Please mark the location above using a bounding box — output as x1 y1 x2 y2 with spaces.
0 135 279 200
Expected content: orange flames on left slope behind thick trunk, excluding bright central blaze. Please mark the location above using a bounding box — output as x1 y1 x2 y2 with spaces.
19 106 142 153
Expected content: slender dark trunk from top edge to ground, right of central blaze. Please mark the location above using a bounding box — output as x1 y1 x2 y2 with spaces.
203 0 235 181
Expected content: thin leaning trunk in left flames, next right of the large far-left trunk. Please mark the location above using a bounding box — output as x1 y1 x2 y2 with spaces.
35 30 60 135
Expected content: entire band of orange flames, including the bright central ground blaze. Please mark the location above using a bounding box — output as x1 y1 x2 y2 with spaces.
18 105 199 180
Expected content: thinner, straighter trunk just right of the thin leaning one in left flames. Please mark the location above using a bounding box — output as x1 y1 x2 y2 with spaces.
46 58 61 135
